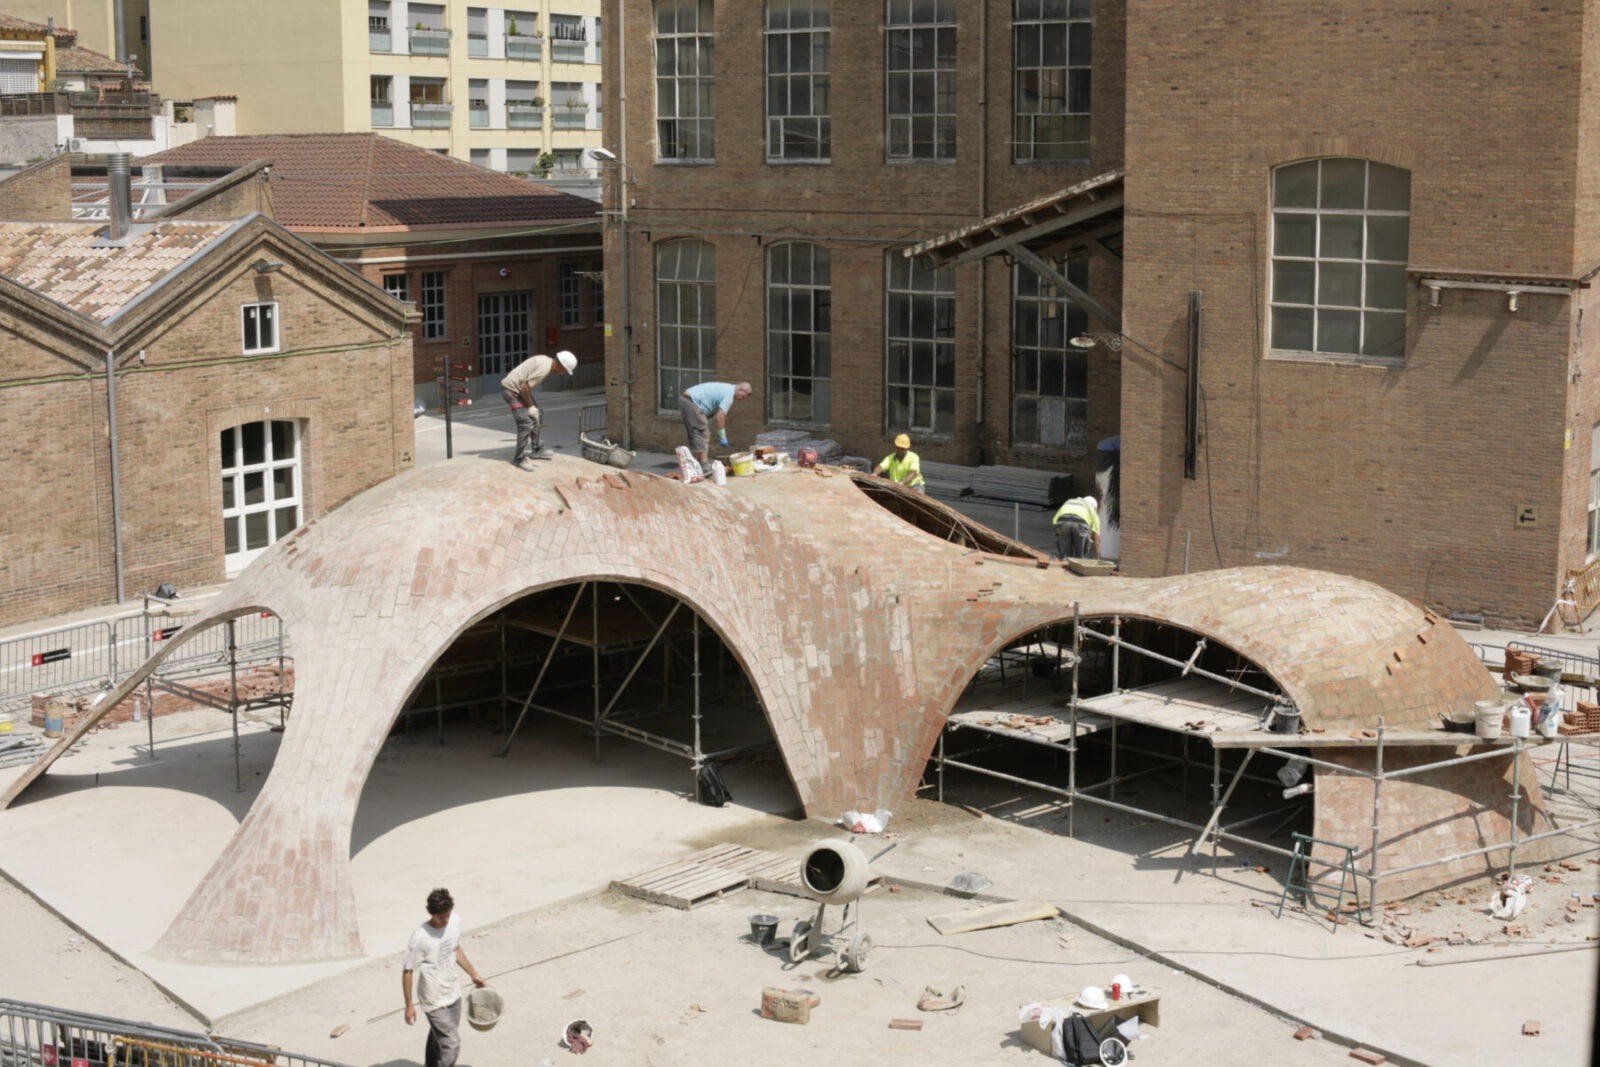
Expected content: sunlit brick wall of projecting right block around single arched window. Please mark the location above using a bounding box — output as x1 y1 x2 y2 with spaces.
1123 0 1594 621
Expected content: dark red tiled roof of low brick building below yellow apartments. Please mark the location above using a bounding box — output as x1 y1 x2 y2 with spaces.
139 133 598 230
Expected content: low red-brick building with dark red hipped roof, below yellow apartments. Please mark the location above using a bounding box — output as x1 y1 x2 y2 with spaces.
139 133 605 405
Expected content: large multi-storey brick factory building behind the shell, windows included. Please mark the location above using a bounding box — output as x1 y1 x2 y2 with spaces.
603 0 1600 621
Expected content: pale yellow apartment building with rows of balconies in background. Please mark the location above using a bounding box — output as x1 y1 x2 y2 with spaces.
154 0 602 176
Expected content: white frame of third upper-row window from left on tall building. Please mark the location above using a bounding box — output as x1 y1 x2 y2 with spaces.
883 0 958 163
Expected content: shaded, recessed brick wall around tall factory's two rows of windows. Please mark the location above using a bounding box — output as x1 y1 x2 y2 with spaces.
605 0 1123 489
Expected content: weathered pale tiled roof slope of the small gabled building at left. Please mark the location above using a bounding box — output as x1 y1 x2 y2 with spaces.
0 221 237 322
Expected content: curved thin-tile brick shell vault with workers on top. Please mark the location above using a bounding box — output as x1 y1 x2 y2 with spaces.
0 458 1494 961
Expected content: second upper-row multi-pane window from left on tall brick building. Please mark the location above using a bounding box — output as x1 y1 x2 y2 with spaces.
766 0 834 160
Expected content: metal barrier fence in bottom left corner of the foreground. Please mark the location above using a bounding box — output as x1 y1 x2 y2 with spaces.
0 1000 342 1067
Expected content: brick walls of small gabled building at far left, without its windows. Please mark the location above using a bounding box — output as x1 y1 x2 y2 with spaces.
0 216 413 624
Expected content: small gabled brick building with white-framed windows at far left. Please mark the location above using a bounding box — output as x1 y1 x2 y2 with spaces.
0 157 413 624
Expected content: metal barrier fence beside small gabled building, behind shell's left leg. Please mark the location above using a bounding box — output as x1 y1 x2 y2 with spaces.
0 613 288 723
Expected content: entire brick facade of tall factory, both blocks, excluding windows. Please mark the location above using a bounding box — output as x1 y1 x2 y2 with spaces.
605 0 1600 621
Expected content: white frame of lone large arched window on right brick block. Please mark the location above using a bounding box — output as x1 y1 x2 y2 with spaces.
1267 155 1411 366
